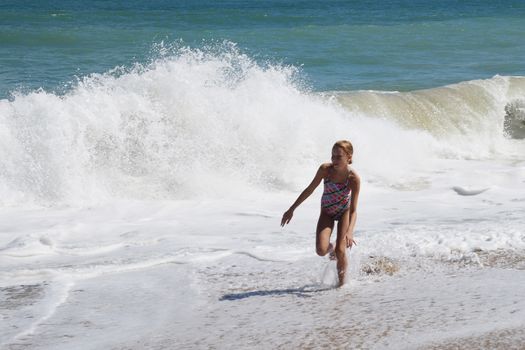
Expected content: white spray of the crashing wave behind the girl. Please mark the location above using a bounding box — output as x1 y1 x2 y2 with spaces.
0 43 519 205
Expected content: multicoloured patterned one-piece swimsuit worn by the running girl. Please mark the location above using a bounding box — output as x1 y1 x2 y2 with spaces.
321 178 350 220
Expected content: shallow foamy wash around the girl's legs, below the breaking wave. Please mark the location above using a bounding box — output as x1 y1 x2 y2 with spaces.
0 189 525 349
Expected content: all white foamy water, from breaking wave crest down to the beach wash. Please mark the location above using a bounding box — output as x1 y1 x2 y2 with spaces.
0 43 525 349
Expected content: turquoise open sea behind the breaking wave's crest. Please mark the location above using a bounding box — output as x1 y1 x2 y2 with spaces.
0 0 525 98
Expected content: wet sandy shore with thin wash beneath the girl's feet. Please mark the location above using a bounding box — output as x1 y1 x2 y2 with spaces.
4 243 525 350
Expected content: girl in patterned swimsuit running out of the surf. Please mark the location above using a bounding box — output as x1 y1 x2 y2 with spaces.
281 140 360 287
